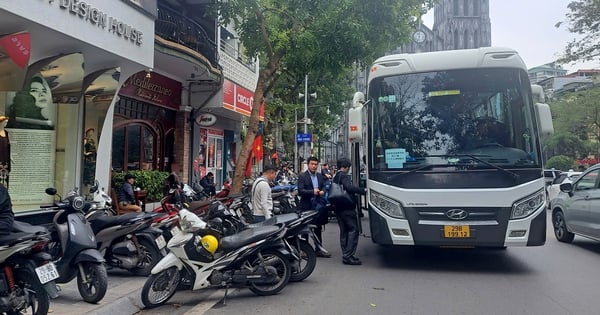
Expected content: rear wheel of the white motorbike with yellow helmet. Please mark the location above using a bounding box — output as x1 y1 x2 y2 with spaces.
250 250 292 295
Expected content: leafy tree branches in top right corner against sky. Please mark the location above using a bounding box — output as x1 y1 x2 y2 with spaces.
556 0 600 63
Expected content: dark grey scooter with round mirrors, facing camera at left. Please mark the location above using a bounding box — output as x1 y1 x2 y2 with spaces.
42 188 108 303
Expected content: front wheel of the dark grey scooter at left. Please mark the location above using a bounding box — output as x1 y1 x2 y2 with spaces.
77 261 108 303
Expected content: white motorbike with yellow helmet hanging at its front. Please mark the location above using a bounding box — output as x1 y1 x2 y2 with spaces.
142 209 291 308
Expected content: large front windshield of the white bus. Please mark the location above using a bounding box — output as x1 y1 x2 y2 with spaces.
368 68 541 171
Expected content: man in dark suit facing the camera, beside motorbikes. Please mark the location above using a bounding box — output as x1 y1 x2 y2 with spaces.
298 156 331 257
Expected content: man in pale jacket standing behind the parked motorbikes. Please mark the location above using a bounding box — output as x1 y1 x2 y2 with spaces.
251 164 277 222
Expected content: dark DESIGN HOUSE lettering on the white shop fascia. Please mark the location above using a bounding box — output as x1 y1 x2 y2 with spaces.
48 0 143 46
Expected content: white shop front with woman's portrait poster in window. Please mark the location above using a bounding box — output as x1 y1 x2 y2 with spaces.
0 0 156 212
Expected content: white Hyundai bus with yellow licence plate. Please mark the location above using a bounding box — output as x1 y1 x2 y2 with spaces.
348 47 553 248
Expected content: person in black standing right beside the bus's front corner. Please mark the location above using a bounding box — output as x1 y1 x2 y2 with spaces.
332 158 367 265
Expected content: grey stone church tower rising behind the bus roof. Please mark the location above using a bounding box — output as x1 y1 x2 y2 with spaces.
433 0 492 50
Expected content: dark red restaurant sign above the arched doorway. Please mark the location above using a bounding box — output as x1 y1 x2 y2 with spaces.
119 71 181 110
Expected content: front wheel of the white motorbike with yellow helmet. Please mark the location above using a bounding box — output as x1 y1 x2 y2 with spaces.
142 267 181 308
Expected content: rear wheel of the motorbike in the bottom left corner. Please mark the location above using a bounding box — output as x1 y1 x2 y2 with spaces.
6 269 50 315
